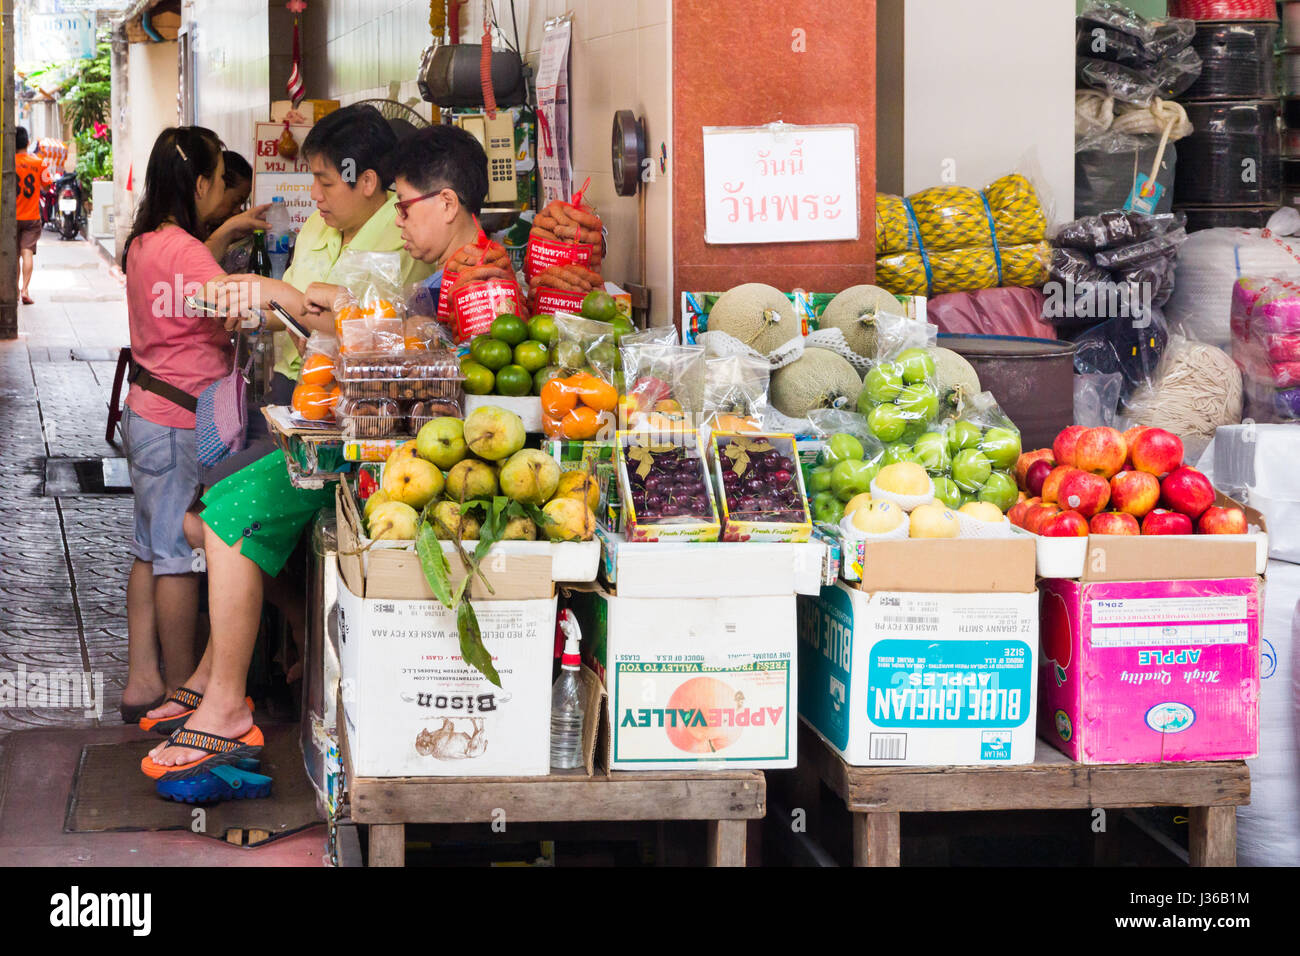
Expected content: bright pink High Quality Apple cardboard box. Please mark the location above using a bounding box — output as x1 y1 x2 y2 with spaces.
1039 578 1264 763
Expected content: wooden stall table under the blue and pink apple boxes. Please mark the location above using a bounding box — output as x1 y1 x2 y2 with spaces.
800 722 1251 866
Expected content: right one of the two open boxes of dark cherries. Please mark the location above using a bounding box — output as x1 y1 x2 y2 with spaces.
712 432 813 541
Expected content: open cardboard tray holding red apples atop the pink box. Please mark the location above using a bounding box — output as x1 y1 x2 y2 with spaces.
1015 492 1269 581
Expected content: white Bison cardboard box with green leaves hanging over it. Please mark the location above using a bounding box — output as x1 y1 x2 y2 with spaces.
338 575 555 777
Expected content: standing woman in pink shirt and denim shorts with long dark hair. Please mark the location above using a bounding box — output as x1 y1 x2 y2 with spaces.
122 126 266 723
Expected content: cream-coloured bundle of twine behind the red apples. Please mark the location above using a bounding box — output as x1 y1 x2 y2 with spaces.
1127 342 1242 441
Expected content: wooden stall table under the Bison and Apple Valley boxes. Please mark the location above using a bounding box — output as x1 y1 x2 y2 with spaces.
341 728 767 866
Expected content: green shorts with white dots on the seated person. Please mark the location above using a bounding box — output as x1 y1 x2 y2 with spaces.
203 450 334 578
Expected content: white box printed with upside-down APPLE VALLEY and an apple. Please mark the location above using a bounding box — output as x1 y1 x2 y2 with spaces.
569 591 797 770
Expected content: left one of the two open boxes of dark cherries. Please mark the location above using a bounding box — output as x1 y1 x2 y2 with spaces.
618 431 722 541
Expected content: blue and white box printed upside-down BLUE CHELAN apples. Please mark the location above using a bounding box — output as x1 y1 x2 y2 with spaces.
798 583 1039 766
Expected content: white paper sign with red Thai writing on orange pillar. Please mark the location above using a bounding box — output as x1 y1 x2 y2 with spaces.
703 124 858 245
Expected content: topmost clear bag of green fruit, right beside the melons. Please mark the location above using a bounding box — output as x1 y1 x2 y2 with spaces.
858 313 940 444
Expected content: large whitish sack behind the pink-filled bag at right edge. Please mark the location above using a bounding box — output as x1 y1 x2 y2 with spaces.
1165 208 1300 349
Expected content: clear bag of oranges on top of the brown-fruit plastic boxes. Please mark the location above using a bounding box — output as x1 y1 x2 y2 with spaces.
334 250 407 354
